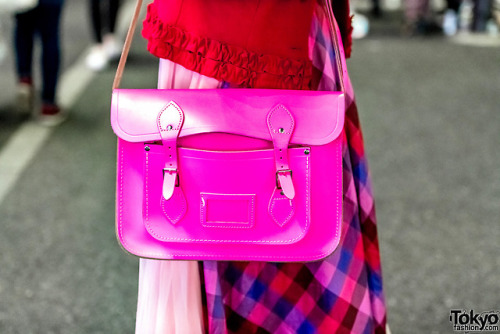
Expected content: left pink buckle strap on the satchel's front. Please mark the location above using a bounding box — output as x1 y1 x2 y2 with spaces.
156 102 184 201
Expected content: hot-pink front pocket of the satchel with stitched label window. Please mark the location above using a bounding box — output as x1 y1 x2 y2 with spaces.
143 144 311 244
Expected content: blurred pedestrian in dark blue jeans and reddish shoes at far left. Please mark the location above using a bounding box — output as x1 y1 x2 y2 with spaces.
14 0 64 125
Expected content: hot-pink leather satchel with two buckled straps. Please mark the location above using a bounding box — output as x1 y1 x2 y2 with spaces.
111 1 345 262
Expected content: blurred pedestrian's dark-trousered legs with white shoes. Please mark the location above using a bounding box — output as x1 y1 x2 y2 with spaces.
87 0 121 71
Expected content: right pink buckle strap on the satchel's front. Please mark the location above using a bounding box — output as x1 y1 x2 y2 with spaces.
267 104 295 199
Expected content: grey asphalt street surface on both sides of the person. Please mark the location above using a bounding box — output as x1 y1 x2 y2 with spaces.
0 0 500 334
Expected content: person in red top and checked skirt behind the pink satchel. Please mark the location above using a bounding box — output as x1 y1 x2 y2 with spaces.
132 0 386 334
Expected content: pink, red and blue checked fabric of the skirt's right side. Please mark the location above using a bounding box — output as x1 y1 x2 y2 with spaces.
201 1 386 334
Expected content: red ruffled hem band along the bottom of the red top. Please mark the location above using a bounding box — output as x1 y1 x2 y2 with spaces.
142 3 312 90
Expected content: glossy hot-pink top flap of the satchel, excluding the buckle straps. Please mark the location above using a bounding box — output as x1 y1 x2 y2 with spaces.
111 89 345 145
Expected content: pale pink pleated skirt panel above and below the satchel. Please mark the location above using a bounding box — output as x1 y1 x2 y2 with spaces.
135 59 221 334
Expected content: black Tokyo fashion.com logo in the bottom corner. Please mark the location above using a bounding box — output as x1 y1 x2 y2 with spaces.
450 310 500 333
